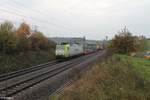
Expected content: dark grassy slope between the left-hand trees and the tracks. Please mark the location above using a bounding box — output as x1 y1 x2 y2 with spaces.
0 50 55 74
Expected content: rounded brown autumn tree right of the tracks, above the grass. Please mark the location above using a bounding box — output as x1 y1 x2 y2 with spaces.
111 28 142 54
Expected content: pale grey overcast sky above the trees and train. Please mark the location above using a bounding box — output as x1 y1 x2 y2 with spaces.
0 0 150 40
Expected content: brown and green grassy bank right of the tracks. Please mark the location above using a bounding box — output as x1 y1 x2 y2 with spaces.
53 55 150 100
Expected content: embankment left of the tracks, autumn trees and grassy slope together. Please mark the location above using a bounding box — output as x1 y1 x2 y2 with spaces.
0 21 55 74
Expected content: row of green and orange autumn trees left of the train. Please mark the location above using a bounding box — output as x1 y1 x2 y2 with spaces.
0 21 55 53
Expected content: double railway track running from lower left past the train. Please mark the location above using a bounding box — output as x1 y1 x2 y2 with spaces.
0 54 96 97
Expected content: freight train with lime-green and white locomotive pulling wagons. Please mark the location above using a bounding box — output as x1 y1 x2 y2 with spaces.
55 43 100 58
